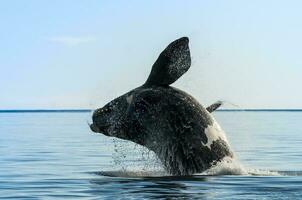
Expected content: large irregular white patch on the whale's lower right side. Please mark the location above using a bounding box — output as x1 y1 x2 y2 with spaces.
202 118 228 149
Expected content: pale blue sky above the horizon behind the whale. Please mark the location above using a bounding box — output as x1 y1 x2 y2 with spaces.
0 0 302 109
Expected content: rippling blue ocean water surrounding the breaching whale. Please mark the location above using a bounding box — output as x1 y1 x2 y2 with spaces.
0 111 302 199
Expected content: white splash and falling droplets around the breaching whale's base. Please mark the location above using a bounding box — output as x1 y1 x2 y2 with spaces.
108 139 288 177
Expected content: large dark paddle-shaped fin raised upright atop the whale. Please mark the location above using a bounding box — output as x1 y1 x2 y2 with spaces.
145 37 191 86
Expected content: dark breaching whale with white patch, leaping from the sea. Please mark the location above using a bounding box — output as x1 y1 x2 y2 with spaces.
90 37 233 175
